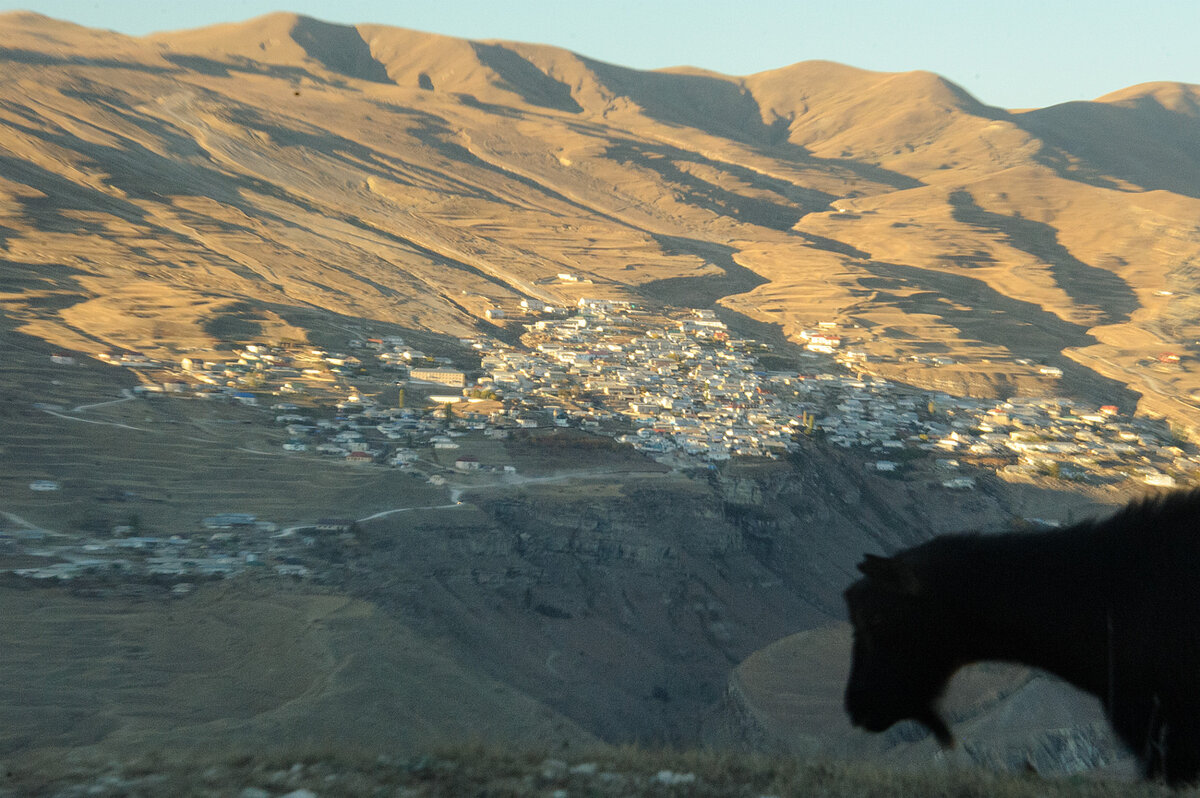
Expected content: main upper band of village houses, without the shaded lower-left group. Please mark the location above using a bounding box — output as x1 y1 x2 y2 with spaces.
88 299 1196 485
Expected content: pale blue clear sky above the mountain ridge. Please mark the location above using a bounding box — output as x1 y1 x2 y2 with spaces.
0 0 1200 108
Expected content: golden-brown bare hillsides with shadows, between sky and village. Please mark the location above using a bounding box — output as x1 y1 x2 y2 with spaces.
0 12 1200 425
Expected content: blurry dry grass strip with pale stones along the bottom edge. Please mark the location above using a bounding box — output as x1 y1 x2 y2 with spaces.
0 744 1174 798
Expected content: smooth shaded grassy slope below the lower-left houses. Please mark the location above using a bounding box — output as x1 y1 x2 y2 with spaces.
0 580 594 758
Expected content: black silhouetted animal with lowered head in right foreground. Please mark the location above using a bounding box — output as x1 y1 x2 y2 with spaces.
845 491 1200 786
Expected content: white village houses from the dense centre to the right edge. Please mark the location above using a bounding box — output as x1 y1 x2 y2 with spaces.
463 301 1198 487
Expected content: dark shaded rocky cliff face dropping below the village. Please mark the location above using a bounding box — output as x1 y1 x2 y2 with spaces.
328 450 1080 744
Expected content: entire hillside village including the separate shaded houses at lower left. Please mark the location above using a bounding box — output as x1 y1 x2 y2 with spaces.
7 300 1200 589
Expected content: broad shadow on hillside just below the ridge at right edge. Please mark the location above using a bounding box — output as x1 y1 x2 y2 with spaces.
1010 97 1200 199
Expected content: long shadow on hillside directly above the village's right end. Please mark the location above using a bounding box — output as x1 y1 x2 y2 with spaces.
859 260 1139 407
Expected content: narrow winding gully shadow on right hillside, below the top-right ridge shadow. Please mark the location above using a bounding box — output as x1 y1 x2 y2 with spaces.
949 191 1140 324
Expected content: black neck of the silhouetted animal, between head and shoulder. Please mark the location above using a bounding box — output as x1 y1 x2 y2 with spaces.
940 530 1111 695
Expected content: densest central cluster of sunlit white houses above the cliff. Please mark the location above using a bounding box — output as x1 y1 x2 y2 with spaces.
470 300 794 460
